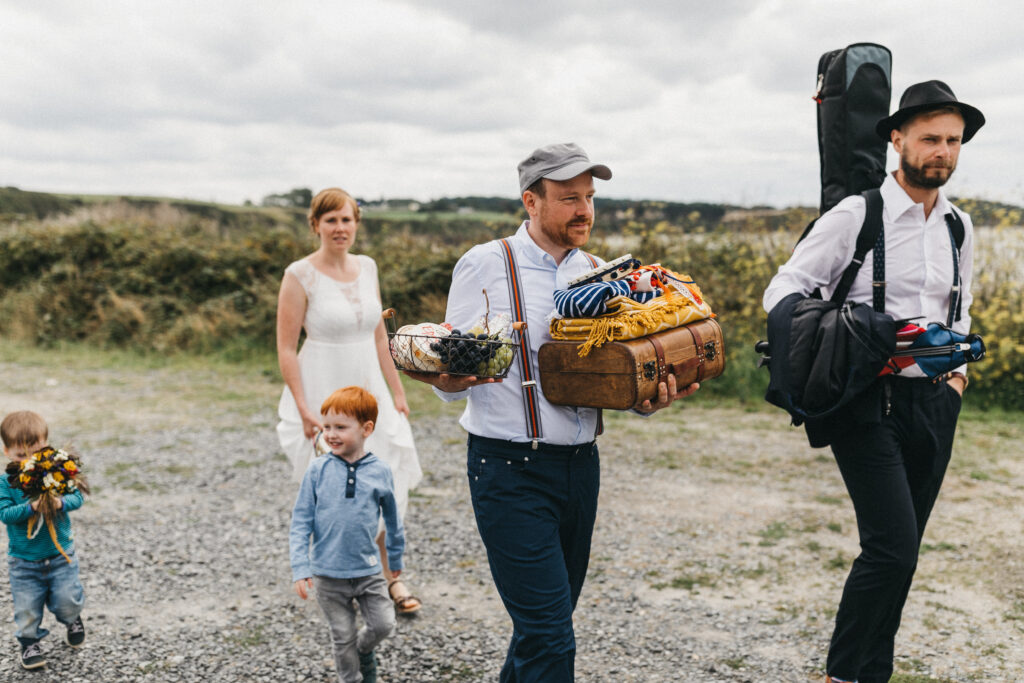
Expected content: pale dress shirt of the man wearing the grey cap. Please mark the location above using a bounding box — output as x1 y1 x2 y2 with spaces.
434 221 603 445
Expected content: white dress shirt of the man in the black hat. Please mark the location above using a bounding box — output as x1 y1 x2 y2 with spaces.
764 175 974 377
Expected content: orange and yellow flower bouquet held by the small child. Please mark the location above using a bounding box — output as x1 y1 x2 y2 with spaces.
7 446 89 562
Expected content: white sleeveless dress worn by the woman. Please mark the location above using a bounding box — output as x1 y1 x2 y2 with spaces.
278 255 423 517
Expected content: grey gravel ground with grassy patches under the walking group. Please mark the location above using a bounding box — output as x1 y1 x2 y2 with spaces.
0 357 1024 683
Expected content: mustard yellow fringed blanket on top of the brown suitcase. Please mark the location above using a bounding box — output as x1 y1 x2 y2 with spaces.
551 275 715 357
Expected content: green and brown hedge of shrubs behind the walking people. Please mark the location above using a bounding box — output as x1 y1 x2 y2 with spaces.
0 210 1024 410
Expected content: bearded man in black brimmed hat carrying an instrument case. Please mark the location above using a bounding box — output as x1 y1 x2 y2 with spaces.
764 81 985 683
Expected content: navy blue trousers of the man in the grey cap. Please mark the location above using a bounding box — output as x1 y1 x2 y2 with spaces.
467 435 600 683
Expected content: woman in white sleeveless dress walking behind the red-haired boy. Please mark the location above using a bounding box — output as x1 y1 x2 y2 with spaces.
278 187 423 613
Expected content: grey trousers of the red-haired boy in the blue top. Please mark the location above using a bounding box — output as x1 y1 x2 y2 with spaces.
313 573 394 683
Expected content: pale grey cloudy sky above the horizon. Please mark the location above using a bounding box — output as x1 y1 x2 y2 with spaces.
0 0 1024 206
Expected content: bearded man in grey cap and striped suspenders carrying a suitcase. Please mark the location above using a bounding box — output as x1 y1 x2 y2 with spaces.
409 143 697 683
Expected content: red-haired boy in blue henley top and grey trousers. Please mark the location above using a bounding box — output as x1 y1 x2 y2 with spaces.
289 386 406 683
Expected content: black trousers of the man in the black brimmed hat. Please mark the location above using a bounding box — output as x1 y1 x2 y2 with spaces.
827 378 961 683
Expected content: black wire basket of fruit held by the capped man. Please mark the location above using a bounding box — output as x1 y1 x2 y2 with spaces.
382 308 526 379
